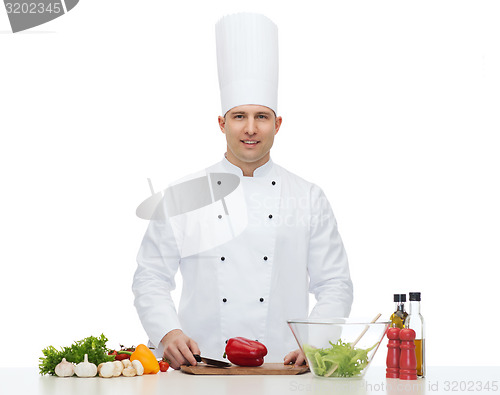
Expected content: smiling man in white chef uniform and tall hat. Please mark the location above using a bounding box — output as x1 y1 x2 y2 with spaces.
133 13 353 369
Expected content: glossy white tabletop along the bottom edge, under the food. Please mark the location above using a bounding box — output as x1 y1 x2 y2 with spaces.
0 366 500 395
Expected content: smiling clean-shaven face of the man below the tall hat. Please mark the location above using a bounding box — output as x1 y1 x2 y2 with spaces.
219 104 282 175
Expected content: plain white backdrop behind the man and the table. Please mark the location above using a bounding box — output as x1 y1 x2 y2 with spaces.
0 0 500 366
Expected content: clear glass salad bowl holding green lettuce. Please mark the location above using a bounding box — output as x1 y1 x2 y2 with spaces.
287 318 390 378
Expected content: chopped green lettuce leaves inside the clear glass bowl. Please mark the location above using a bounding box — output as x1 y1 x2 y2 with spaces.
302 340 378 377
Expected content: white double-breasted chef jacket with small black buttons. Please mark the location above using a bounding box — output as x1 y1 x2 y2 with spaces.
132 158 353 362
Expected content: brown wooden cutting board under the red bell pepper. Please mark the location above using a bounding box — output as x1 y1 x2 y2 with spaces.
181 363 309 375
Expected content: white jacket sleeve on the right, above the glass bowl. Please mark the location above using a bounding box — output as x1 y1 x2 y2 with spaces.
308 185 353 318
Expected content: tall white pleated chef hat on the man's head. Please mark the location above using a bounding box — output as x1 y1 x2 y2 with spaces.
215 13 278 114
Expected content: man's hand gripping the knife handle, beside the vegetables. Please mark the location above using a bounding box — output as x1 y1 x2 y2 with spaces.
161 329 200 370
